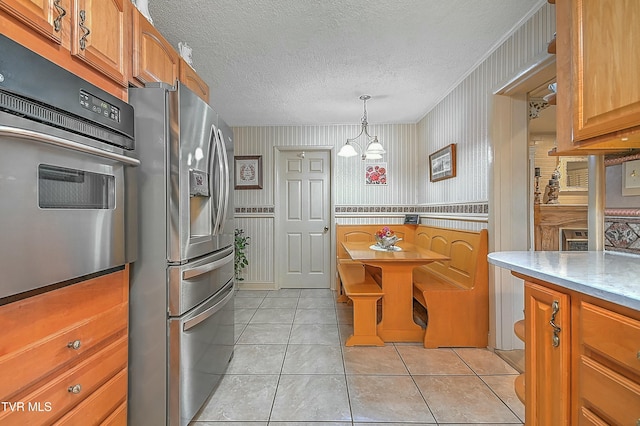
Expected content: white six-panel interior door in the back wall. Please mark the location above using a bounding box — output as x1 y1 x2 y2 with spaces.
276 151 331 288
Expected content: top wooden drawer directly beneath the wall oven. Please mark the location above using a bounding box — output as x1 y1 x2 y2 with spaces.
0 271 128 400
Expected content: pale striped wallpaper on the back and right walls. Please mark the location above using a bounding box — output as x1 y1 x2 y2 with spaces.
234 2 555 288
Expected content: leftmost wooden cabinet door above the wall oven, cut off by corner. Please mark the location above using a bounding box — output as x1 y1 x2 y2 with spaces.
0 0 68 44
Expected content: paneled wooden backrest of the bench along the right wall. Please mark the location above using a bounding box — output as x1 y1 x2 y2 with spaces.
414 225 489 289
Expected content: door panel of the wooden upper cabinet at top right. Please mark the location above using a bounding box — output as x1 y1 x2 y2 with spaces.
571 0 640 141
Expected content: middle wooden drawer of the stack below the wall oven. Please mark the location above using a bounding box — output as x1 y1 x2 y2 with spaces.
0 335 127 426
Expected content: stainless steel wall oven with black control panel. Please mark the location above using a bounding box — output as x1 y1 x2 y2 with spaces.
0 35 139 303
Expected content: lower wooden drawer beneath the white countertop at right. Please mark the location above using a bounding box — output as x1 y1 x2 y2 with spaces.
578 356 640 425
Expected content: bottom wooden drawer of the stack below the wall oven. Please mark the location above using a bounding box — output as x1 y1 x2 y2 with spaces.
55 368 127 426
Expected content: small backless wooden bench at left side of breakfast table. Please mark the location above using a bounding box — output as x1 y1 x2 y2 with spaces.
338 262 384 346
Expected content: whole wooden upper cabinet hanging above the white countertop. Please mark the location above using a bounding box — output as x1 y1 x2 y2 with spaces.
556 0 640 154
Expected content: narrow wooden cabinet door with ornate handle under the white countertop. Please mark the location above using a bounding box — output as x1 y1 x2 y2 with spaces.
524 282 571 425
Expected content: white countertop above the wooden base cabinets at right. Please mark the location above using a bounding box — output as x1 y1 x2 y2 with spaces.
488 251 640 311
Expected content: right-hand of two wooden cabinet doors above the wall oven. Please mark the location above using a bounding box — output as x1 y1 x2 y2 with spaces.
71 0 130 87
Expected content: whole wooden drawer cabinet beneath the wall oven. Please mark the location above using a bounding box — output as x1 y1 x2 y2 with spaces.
0 267 129 426
